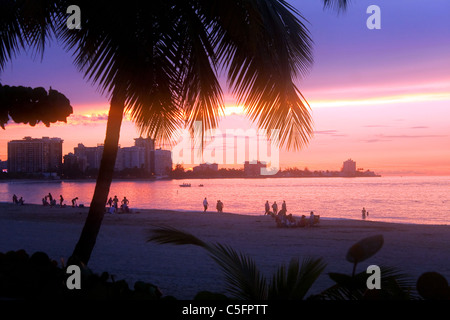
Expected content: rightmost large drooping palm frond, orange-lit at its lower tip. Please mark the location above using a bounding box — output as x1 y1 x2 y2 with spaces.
203 0 313 149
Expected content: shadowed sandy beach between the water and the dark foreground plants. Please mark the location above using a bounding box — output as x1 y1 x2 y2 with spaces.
0 203 450 299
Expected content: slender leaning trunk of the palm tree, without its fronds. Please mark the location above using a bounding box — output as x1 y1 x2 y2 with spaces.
68 93 125 265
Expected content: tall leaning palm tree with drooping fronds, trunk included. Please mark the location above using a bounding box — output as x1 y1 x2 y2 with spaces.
0 0 347 264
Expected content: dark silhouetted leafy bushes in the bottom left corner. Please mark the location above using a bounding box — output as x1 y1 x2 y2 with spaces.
0 250 164 300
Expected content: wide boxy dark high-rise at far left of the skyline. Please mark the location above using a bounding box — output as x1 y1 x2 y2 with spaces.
8 137 63 174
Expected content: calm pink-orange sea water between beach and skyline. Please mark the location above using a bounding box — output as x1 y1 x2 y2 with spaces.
0 177 450 225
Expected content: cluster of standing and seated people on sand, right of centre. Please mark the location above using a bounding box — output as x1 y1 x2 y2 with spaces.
264 200 320 227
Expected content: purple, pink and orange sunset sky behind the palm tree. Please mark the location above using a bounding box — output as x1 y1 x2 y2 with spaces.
0 0 450 175
